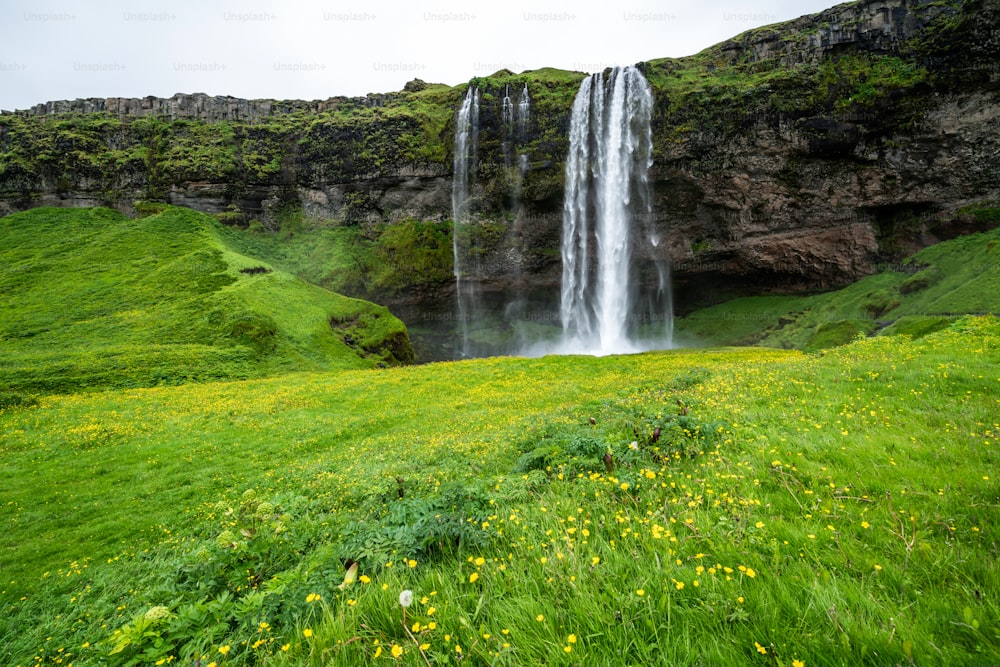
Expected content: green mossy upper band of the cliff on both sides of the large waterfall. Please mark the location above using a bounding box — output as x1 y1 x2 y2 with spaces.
0 0 992 215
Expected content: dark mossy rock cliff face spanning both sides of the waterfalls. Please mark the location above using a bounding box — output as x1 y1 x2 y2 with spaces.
0 0 1000 320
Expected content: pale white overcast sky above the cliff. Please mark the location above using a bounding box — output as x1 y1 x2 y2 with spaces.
0 0 837 110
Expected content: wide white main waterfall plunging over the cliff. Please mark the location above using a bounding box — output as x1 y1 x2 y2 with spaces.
559 67 672 355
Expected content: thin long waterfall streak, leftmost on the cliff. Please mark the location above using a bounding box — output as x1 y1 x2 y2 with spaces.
451 86 479 356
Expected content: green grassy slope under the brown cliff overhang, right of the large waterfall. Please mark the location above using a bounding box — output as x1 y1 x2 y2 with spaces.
676 207 1000 350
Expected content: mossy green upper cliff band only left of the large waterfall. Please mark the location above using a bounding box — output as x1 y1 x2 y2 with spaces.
0 70 582 205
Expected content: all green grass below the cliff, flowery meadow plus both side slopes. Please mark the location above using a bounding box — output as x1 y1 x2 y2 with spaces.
0 208 1000 667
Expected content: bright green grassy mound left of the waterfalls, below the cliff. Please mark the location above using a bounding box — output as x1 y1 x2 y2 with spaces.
0 208 412 392
